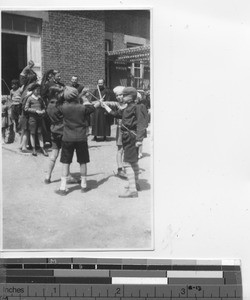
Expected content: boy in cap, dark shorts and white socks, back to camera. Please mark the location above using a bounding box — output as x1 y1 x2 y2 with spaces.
56 86 100 196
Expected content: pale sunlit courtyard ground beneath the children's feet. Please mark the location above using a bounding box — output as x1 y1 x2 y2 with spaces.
2 125 153 250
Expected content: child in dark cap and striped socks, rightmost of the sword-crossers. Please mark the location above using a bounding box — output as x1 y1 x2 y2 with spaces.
102 87 148 198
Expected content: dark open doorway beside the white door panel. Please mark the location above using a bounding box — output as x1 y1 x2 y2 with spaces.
2 33 27 95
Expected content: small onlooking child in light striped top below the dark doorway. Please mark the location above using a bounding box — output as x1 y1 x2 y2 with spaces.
10 79 22 132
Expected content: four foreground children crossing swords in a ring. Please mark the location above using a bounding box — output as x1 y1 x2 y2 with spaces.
45 86 148 198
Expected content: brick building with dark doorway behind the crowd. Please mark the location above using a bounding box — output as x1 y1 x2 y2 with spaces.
1 10 150 94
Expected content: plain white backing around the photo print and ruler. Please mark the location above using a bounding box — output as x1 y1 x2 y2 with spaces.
1 0 250 299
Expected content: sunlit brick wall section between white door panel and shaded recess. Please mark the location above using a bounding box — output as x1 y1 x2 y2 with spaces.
42 11 105 88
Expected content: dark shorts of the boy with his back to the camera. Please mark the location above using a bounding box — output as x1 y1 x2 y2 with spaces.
60 141 89 164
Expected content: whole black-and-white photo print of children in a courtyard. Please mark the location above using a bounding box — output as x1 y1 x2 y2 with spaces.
1 8 154 251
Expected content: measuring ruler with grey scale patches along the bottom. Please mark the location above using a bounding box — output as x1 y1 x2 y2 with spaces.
0 258 242 300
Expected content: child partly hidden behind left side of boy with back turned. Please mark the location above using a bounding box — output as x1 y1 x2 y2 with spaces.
44 86 78 184
